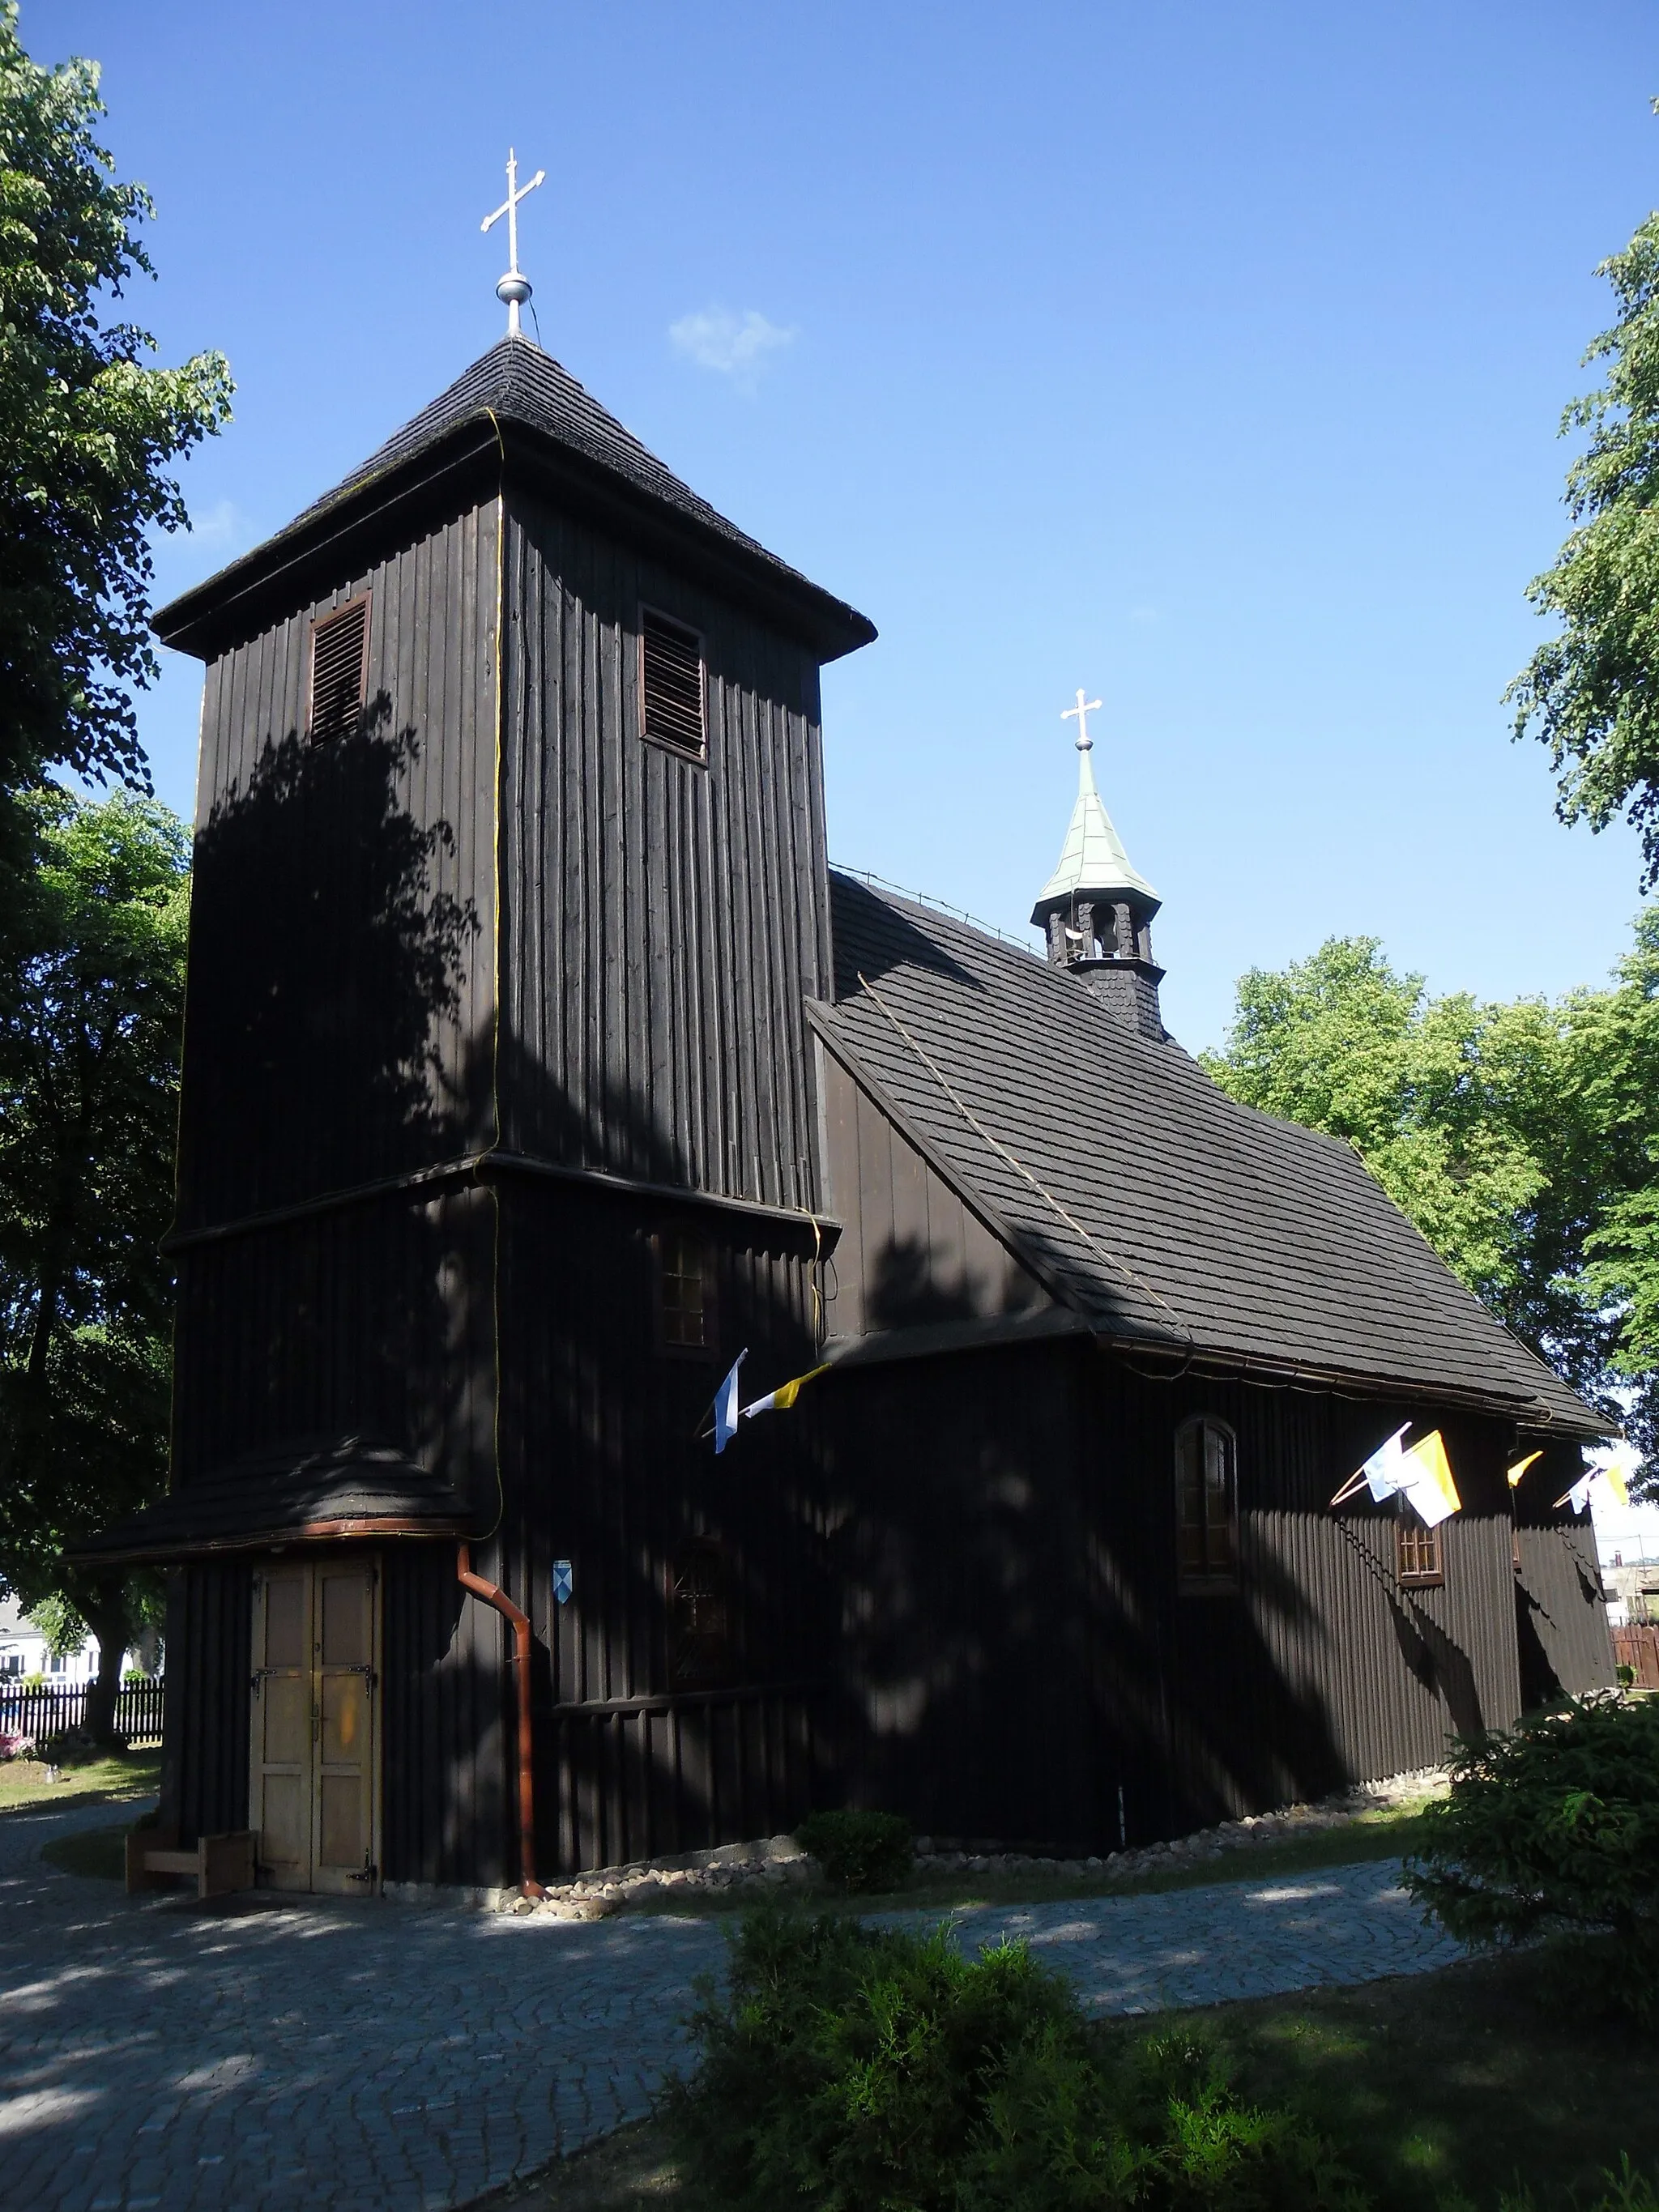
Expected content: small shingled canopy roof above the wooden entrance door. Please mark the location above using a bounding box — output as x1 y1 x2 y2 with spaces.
73 1435 467 1566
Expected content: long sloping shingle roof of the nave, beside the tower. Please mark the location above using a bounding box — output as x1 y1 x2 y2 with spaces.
812 874 1606 1435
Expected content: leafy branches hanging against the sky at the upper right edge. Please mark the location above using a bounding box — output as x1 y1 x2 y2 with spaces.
1504 201 1659 887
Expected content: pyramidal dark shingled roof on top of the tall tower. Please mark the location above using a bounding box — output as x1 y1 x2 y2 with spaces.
155 336 876 653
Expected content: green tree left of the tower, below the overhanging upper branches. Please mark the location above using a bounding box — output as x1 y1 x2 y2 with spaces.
0 787 188 1734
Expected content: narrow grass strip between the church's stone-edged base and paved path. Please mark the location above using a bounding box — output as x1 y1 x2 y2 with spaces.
629 1807 1422 1913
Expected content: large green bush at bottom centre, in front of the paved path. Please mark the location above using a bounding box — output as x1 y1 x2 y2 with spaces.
663 1912 1365 2212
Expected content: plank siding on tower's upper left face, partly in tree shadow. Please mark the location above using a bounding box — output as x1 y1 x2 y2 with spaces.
179 502 497 1230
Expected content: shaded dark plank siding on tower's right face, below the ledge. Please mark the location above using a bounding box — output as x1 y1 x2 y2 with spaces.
484 1177 832 1869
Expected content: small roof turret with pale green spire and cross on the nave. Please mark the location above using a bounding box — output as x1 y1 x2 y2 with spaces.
1030 693 1166 1044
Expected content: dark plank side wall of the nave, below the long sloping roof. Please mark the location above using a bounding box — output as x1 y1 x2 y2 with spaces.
821 1345 1575 1849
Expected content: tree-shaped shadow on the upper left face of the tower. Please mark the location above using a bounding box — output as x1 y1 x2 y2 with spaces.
179 695 491 1228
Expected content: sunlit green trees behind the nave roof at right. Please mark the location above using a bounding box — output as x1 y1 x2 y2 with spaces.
1203 909 1659 1460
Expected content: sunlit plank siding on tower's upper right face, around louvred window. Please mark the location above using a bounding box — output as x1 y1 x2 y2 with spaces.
500 496 830 1205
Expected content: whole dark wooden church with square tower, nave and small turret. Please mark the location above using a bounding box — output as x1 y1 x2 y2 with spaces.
75 280 1610 1894
